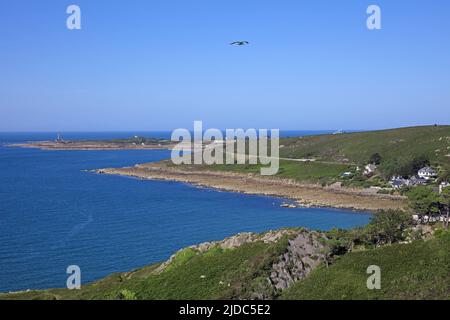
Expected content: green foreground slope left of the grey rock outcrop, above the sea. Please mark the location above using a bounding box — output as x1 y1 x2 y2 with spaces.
0 237 287 300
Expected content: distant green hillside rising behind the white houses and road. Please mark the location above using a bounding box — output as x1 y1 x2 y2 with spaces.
280 126 450 164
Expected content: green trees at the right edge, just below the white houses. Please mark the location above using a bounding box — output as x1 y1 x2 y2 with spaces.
407 186 450 229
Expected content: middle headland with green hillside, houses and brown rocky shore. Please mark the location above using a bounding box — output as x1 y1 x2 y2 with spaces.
93 126 450 210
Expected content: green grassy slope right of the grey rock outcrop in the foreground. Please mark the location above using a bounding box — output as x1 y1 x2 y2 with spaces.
282 233 450 300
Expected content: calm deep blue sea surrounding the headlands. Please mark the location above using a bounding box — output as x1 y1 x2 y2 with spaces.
0 131 370 292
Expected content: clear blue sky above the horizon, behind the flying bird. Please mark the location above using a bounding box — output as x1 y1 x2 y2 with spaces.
0 0 450 131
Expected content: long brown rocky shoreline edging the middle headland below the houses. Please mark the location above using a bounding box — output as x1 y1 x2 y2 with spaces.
94 162 406 212
